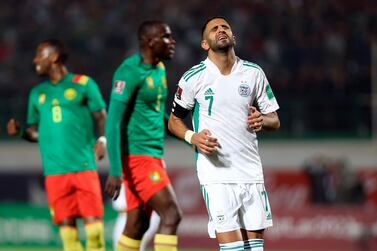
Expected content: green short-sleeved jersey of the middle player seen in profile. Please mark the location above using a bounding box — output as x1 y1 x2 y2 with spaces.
111 54 167 158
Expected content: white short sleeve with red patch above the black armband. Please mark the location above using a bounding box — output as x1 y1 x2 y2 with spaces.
174 77 195 110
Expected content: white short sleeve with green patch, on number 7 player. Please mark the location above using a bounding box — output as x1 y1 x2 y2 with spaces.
255 67 279 114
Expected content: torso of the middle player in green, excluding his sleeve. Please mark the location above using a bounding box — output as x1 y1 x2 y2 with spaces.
122 64 167 157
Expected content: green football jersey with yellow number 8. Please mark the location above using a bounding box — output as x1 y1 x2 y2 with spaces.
27 73 106 175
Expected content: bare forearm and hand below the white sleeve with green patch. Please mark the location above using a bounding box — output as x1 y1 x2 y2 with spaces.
247 106 280 132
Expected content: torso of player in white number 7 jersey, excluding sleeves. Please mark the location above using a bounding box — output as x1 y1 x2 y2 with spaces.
193 60 263 183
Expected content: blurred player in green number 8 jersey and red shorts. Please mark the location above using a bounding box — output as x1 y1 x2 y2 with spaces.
7 39 106 251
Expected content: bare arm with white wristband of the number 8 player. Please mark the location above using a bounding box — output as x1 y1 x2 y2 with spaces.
92 109 106 160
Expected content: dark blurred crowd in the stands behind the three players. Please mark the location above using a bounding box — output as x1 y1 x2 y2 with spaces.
0 0 377 136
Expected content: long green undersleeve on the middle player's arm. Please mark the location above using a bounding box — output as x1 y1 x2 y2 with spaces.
105 100 127 177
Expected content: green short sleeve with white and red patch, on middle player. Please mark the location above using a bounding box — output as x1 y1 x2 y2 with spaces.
110 64 141 104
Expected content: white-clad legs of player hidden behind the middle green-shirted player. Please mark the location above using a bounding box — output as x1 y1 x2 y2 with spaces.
112 184 161 251
